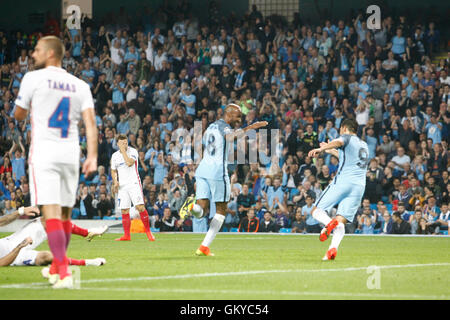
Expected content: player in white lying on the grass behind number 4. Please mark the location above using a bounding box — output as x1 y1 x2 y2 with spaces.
0 207 108 267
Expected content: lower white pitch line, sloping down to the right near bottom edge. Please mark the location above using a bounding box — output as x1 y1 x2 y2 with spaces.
0 283 450 300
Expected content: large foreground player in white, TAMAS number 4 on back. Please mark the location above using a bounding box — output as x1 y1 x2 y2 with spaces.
14 36 98 289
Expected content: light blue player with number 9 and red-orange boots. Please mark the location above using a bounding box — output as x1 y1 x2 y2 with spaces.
308 119 369 260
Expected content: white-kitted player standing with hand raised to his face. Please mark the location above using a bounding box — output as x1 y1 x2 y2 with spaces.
111 134 155 241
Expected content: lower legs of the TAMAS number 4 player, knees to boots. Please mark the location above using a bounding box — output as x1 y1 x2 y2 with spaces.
41 204 73 288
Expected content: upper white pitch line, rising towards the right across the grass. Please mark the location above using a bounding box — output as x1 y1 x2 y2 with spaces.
0 262 450 289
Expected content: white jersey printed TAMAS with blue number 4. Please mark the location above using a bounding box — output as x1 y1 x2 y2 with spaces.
15 66 94 163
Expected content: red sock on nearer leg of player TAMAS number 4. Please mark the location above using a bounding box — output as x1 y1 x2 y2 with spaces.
46 219 70 279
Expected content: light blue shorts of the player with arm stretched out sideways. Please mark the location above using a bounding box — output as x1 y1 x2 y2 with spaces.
195 177 231 202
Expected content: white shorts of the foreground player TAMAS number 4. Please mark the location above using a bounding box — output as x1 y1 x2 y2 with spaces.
29 162 79 208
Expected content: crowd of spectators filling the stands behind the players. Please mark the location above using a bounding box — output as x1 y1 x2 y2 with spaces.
0 0 450 234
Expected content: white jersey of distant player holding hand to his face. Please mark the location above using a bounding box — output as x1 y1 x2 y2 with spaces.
111 147 141 187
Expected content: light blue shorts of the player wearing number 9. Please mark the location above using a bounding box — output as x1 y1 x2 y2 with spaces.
314 182 365 222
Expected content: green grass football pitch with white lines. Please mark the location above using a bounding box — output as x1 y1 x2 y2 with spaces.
0 233 450 300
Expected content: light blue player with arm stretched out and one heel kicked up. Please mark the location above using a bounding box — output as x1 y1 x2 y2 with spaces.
180 104 267 256
